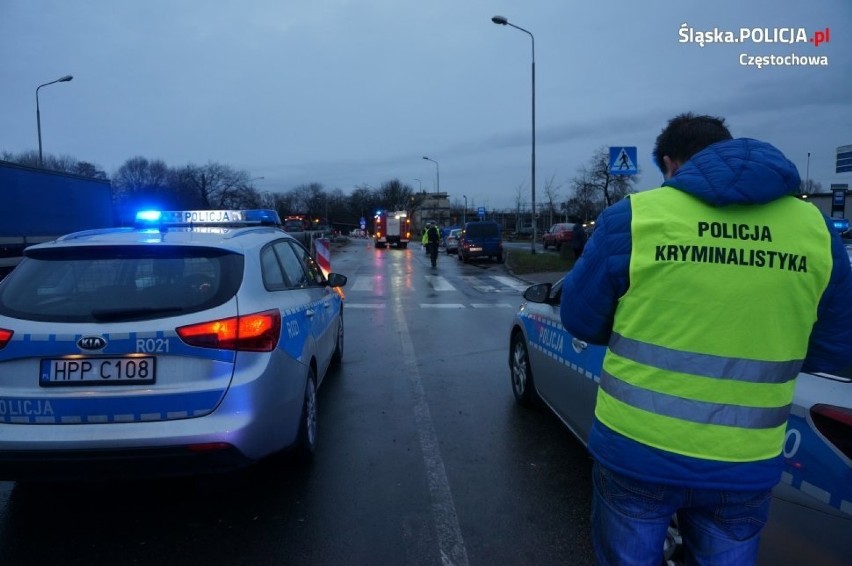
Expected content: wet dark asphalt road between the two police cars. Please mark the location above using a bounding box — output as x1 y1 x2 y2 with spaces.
0 240 591 566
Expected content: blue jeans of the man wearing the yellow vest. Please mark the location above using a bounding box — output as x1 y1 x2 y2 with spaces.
592 462 772 566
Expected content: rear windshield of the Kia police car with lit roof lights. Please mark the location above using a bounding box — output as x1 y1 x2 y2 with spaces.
0 246 243 322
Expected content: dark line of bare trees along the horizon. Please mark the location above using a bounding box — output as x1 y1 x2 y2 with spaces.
0 147 821 230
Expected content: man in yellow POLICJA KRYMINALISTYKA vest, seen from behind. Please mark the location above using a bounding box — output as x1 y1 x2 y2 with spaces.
560 114 852 566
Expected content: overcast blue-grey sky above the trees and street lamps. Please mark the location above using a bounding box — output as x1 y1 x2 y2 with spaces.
0 0 852 210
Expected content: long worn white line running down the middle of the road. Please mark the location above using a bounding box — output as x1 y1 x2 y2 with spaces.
392 295 468 566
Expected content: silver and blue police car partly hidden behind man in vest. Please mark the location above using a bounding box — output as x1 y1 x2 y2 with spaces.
508 281 852 564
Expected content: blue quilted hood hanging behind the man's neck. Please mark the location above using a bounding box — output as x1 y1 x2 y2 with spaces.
663 138 801 206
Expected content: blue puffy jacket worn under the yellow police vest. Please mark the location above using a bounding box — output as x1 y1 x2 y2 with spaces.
561 138 852 490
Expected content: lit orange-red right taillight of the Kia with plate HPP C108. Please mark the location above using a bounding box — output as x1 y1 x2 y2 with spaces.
176 310 281 352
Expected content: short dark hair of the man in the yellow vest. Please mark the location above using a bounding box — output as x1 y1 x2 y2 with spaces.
654 112 733 175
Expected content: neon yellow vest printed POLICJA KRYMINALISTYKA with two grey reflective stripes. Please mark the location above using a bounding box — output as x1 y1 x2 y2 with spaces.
595 188 832 462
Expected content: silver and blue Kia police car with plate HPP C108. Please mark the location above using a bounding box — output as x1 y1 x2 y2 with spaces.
0 210 346 480
